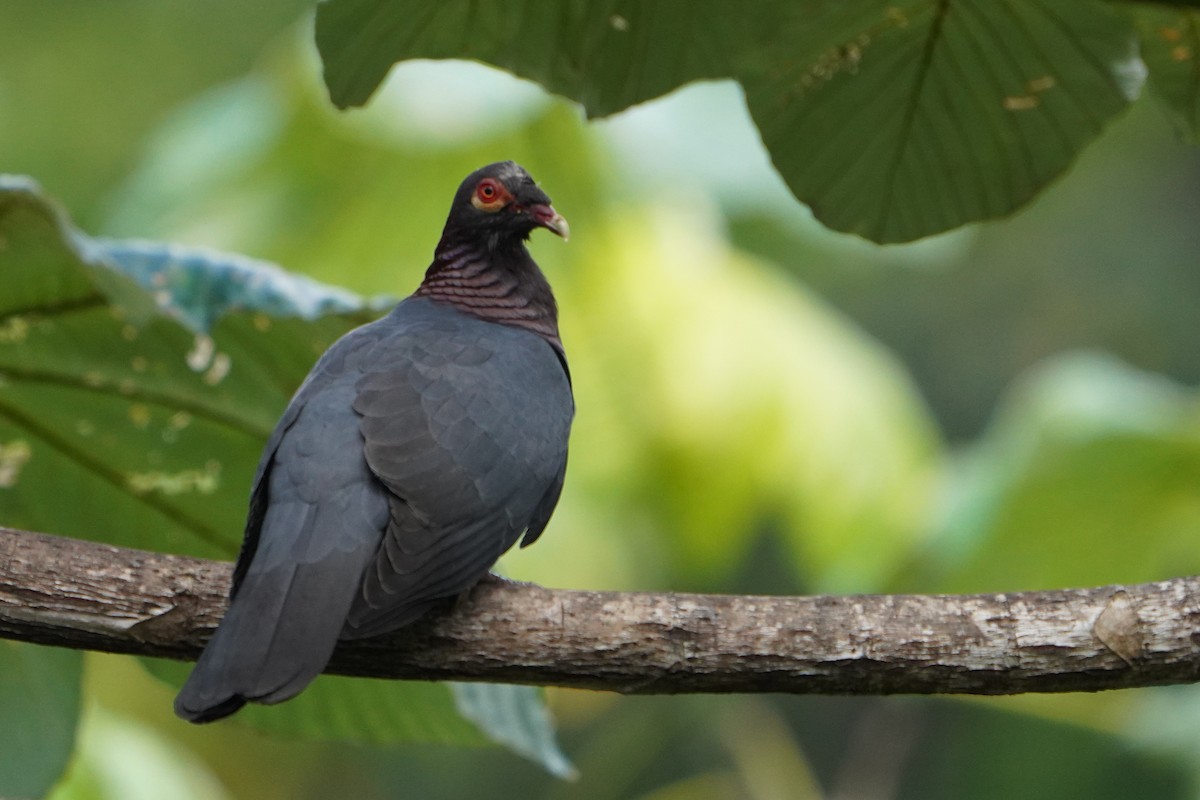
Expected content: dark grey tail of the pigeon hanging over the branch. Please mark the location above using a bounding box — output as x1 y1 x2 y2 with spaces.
175 549 371 722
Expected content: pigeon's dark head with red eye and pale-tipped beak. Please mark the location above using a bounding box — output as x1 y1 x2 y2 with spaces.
442 161 570 248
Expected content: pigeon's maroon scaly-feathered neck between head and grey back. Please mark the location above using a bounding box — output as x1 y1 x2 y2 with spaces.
415 236 563 353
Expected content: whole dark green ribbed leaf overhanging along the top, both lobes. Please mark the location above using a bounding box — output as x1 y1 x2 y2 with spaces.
317 0 1145 242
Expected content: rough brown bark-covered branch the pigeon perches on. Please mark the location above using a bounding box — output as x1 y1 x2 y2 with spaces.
0 528 1200 694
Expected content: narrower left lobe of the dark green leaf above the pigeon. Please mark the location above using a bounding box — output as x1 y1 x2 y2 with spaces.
316 0 751 116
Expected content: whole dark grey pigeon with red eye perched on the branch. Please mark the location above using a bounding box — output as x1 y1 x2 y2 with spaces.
175 161 575 722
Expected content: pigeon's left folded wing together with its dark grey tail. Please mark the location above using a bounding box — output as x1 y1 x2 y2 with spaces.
175 321 389 722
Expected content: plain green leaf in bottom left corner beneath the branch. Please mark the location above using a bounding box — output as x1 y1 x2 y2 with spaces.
0 640 83 800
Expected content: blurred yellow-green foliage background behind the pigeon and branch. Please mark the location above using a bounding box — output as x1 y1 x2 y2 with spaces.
7 0 1200 800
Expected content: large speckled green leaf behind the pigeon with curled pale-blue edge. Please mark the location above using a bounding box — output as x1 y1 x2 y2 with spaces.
0 178 571 759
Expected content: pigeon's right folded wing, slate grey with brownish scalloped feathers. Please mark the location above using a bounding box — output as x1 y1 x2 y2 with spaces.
344 309 574 637
